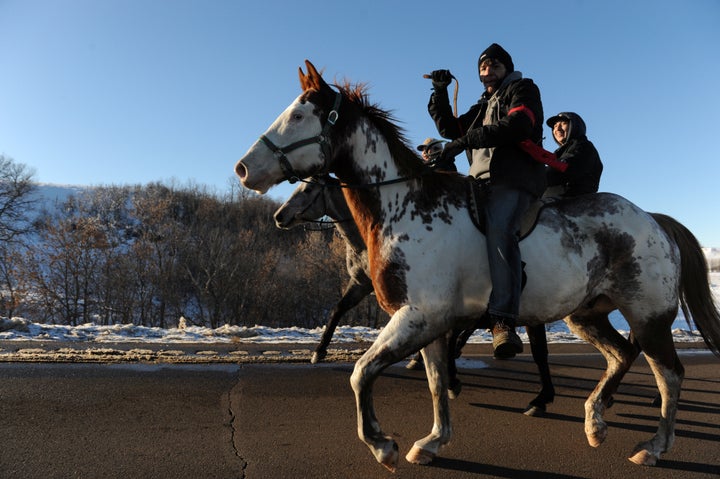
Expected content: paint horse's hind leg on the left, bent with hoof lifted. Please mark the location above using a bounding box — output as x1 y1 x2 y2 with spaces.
565 311 638 447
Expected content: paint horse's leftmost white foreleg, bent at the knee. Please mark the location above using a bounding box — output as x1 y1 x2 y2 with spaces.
350 306 442 471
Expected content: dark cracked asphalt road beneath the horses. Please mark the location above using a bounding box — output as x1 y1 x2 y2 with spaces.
0 345 720 479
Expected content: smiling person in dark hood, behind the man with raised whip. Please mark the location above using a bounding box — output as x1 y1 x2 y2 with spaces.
546 111 603 197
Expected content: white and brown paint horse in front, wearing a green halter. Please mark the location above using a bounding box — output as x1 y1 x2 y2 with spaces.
235 61 720 470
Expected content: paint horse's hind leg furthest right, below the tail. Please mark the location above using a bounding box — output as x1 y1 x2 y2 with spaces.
629 313 685 466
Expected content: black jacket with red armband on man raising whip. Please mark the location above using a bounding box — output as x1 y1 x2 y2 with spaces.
428 72 546 196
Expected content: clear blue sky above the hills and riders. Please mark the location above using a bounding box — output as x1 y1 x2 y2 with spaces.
0 0 720 247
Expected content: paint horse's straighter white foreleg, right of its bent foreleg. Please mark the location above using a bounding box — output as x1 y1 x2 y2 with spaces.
405 336 452 464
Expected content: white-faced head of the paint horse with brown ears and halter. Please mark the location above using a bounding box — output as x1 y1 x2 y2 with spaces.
235 60 342 194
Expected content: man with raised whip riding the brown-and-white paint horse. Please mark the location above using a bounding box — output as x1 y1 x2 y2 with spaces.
428 43 546 359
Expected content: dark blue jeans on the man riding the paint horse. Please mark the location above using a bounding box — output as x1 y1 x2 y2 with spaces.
485 185 533 324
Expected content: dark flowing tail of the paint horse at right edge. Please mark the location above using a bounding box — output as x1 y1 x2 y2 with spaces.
650 213 720 357
